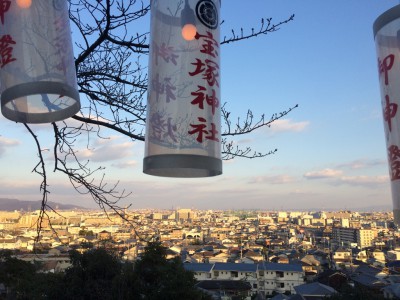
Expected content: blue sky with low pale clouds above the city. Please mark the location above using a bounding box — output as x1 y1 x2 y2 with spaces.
0 0 399 211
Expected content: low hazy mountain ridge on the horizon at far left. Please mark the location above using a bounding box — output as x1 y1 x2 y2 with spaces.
0 198 86 211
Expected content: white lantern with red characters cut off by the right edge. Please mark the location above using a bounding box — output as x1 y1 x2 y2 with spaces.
373 5 400 225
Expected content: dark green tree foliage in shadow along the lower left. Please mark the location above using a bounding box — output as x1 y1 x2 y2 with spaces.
0 242 212 300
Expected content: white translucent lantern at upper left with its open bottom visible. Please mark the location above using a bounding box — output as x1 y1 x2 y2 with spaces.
0 0 80 123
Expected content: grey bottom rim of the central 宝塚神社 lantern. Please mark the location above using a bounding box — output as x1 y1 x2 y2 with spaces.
143 154 222 178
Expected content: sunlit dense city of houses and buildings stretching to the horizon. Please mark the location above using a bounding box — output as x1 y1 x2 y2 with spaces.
0 208 400 299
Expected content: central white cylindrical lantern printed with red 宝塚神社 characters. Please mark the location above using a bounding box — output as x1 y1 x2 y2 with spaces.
143 0 222 177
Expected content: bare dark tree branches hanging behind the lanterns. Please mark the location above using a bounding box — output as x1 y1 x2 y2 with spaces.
16 0 297 236
